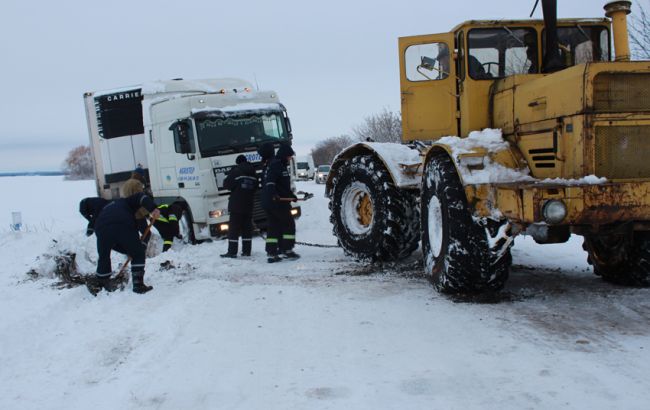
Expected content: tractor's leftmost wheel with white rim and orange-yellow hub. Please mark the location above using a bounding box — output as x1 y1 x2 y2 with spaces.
329 155 420 261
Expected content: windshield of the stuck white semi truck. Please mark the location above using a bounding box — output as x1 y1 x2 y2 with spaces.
190 113 288 157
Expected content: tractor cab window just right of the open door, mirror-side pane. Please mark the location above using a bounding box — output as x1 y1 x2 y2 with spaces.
467 27 539 80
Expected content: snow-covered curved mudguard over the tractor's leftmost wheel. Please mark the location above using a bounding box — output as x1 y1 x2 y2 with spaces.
325 142 422 197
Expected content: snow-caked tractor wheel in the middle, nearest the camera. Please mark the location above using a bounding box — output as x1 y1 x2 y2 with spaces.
421 153 512 293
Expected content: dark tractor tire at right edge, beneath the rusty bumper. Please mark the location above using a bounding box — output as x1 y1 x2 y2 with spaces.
582 232 650 286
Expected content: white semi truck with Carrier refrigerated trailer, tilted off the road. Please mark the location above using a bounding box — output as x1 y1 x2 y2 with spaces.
84 78 300 242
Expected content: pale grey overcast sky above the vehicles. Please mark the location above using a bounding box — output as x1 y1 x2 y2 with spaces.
0 0 606 172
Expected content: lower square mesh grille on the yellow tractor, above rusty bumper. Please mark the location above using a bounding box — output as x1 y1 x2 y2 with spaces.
595 125 650 179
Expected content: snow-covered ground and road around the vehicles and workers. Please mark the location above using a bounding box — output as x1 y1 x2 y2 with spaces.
0 177 650 410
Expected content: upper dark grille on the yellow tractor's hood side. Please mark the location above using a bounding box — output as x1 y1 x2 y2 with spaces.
594 73 650 112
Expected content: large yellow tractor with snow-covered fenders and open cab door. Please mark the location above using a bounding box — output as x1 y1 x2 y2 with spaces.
326 0 650 293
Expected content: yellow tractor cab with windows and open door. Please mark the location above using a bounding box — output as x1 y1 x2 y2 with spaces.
399 19 611 141
